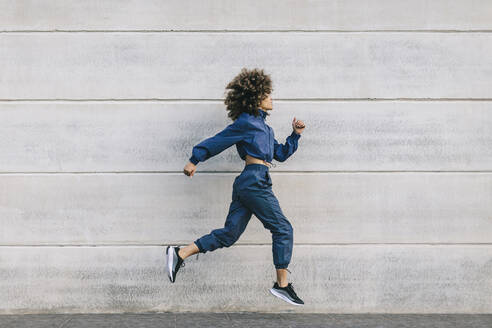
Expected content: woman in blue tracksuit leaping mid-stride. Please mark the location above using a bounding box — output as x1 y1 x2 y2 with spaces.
170 68 305 305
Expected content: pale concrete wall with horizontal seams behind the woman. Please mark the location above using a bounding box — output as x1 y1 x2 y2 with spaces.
0 0 492 313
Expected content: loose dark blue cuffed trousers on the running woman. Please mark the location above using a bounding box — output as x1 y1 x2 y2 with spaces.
195 163 294 269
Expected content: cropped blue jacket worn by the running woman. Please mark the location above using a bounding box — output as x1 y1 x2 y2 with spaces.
190 109 301 165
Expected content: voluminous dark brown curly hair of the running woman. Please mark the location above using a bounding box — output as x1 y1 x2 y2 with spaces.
224 68 273 121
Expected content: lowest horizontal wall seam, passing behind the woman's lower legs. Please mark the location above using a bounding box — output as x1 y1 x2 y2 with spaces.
0 242 492 247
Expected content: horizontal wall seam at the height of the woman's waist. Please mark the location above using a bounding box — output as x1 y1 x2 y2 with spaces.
0 169 492 179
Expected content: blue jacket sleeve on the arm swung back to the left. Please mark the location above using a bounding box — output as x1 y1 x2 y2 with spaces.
190 119 246 165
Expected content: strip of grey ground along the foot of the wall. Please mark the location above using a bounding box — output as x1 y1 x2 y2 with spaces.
0 312 492 328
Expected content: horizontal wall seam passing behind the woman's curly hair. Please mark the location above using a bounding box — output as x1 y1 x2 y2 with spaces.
0 97 492 103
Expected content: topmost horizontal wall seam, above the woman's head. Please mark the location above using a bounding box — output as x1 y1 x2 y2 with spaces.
0 29 492 34
